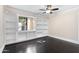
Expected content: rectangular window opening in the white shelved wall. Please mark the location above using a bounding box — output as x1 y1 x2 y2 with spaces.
18 16 36 31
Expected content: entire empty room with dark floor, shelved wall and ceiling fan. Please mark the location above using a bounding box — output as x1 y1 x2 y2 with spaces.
0 5 79 53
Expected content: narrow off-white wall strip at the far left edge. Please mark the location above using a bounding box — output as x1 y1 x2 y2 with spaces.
0 5 5 52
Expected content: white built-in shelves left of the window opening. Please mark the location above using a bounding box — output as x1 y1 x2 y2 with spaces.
4 10 17 44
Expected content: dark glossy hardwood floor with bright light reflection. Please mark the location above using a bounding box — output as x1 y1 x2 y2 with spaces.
3 36 79 53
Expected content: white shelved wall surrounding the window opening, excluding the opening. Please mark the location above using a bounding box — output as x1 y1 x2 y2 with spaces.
4 6 48 44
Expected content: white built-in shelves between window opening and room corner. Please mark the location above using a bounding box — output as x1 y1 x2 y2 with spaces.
36 18 48 34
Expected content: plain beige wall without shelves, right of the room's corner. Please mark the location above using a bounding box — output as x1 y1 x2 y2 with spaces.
48 8 79 41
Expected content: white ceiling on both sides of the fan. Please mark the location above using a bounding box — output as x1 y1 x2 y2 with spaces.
10 5 79 13
